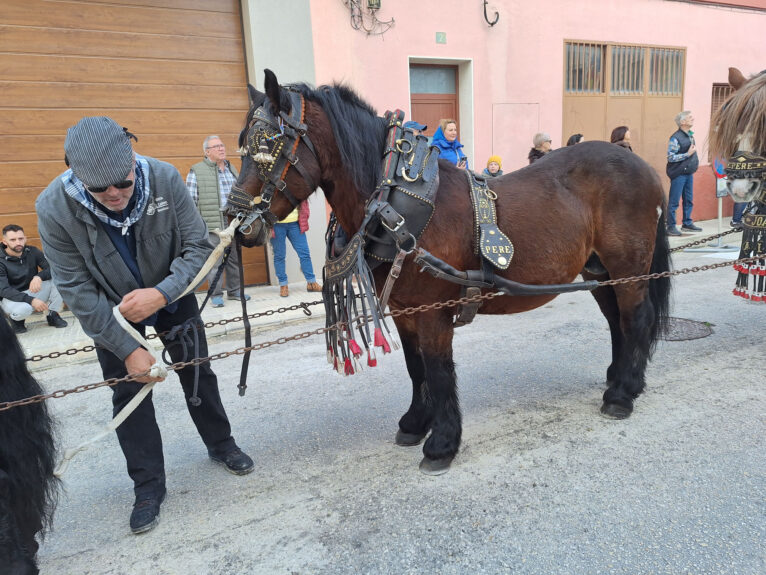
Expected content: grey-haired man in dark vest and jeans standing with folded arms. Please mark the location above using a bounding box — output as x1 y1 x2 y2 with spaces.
665 110 702 236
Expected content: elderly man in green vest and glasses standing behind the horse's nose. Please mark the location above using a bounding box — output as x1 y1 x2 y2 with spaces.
186 135 250 307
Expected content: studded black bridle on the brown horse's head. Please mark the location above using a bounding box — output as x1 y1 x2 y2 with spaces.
228 88 316 235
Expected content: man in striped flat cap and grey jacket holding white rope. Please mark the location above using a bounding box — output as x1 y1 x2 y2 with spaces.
35 117 253 533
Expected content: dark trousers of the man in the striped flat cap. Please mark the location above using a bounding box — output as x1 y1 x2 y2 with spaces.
96 294 236 499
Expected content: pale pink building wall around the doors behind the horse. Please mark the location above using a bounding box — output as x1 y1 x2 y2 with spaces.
310 0 766 180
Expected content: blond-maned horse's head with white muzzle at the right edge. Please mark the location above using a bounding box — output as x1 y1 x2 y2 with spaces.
710 68 766 202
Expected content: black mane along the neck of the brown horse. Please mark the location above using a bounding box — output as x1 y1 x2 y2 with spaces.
289 84 386 197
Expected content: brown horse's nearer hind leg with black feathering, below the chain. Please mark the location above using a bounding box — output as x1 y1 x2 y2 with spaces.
601 282 656 419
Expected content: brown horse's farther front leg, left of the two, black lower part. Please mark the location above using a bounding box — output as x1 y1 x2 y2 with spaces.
394 316 432 446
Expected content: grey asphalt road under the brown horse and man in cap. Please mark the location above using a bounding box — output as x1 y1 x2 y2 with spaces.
37 249 766 575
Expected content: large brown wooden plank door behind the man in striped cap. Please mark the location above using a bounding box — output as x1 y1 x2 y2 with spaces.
0 0 268 284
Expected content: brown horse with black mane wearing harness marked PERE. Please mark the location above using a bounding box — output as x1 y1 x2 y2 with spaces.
229 70 670 474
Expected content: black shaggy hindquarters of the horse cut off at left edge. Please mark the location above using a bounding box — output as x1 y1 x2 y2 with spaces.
0 317 59 575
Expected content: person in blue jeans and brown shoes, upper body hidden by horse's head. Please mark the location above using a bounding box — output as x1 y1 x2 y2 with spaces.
271 201 322 297
